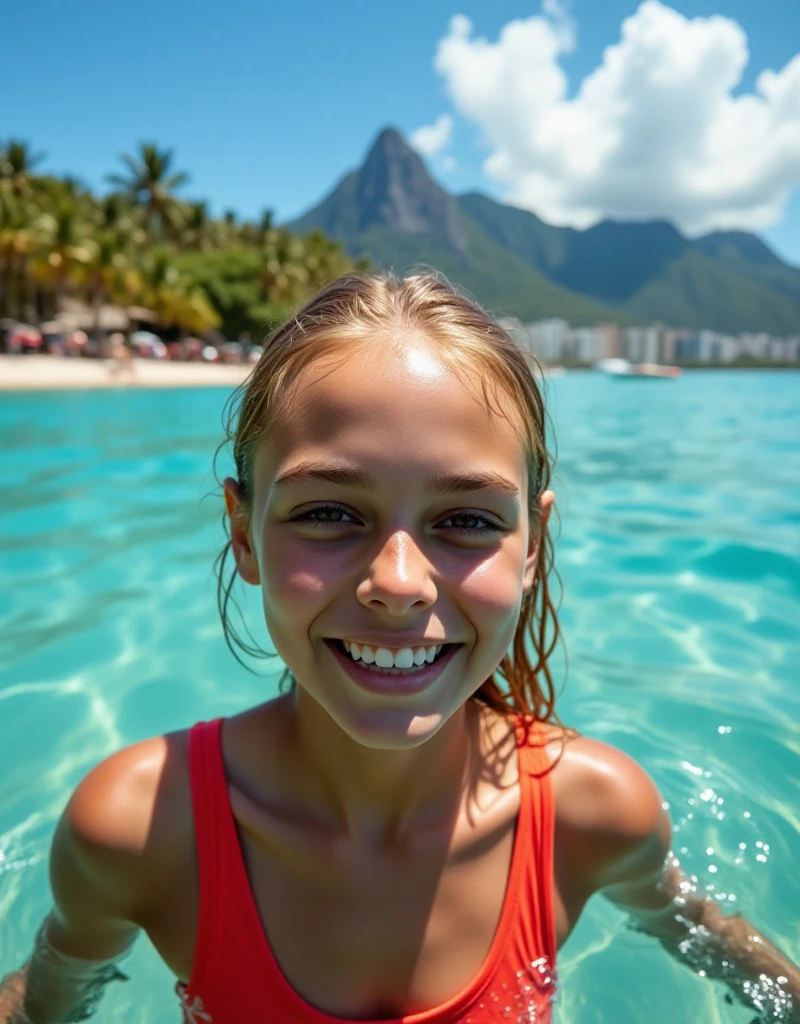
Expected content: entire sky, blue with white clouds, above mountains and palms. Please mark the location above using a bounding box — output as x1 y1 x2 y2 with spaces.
6 0 800 265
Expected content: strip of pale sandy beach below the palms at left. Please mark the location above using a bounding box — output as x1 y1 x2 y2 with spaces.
0 355 252 391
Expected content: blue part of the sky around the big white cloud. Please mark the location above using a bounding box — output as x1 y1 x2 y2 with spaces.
6 0 800 264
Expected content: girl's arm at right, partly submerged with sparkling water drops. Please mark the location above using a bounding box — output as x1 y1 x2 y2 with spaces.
590 752 800 1024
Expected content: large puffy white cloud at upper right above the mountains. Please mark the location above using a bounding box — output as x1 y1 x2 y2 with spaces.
434 0 800 233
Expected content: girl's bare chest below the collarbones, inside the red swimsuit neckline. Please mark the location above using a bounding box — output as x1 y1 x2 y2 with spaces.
248 811 514 1019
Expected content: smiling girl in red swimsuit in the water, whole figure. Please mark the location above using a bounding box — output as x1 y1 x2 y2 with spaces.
0 274 800 1024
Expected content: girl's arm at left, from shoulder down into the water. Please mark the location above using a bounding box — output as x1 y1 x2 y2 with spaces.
0 744 163 1024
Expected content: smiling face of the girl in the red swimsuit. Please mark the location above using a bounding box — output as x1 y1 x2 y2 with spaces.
225 337 553 749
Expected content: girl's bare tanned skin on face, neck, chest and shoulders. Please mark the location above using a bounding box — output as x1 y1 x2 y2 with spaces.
26 337 704 1019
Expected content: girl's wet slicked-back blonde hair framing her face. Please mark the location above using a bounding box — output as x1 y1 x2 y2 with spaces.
215 273 560 722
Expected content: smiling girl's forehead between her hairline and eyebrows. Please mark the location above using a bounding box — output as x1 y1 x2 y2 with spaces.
257 338 527 490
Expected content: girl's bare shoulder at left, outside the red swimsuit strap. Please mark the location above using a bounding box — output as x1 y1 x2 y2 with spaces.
51 732 194 923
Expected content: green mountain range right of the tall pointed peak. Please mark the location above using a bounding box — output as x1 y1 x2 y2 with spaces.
457 193 800 335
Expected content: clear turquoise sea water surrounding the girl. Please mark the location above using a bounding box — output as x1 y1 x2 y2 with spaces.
0 372 800 1024
